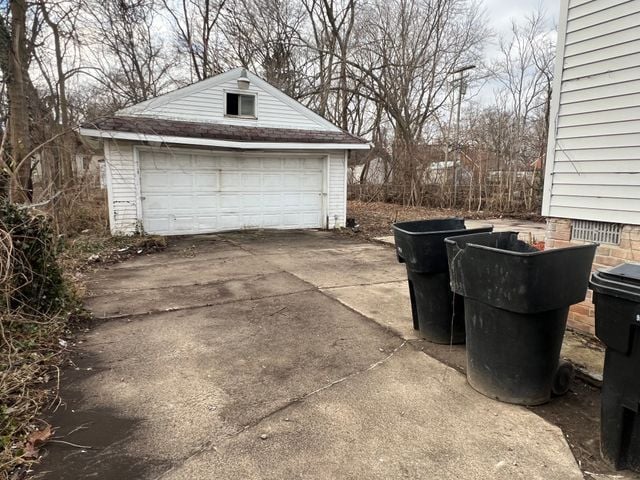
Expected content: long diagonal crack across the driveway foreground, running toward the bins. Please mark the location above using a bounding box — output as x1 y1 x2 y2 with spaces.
153 340 408 480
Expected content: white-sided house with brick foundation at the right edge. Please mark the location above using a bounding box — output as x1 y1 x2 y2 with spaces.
542 0 640 332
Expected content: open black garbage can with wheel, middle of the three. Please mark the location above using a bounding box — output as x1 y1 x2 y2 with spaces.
445 232 597 405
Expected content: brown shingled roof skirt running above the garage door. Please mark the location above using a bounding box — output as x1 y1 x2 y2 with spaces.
81 116 369 148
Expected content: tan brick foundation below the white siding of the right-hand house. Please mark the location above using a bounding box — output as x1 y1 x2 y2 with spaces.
545 218 640 335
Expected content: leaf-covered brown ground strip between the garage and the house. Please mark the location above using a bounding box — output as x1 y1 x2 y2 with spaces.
347 200 544 237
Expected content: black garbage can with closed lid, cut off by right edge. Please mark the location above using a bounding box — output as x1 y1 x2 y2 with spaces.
590 263 640 472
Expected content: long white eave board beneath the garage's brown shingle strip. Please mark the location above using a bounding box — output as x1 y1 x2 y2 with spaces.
80 128 371 150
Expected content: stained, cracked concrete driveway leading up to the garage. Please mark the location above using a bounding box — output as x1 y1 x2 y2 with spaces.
38 232 582 480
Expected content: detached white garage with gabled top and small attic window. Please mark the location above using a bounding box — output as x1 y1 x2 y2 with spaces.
80 68 369 235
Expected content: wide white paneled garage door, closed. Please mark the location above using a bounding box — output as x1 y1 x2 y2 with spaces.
139 150 325 235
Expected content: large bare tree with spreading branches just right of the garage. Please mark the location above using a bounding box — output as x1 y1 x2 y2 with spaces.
350 0 487 204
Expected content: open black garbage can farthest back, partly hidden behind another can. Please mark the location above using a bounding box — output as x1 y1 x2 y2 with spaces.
393 218 493 344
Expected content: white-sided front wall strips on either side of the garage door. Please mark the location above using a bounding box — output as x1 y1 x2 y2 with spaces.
104 140 346 235
